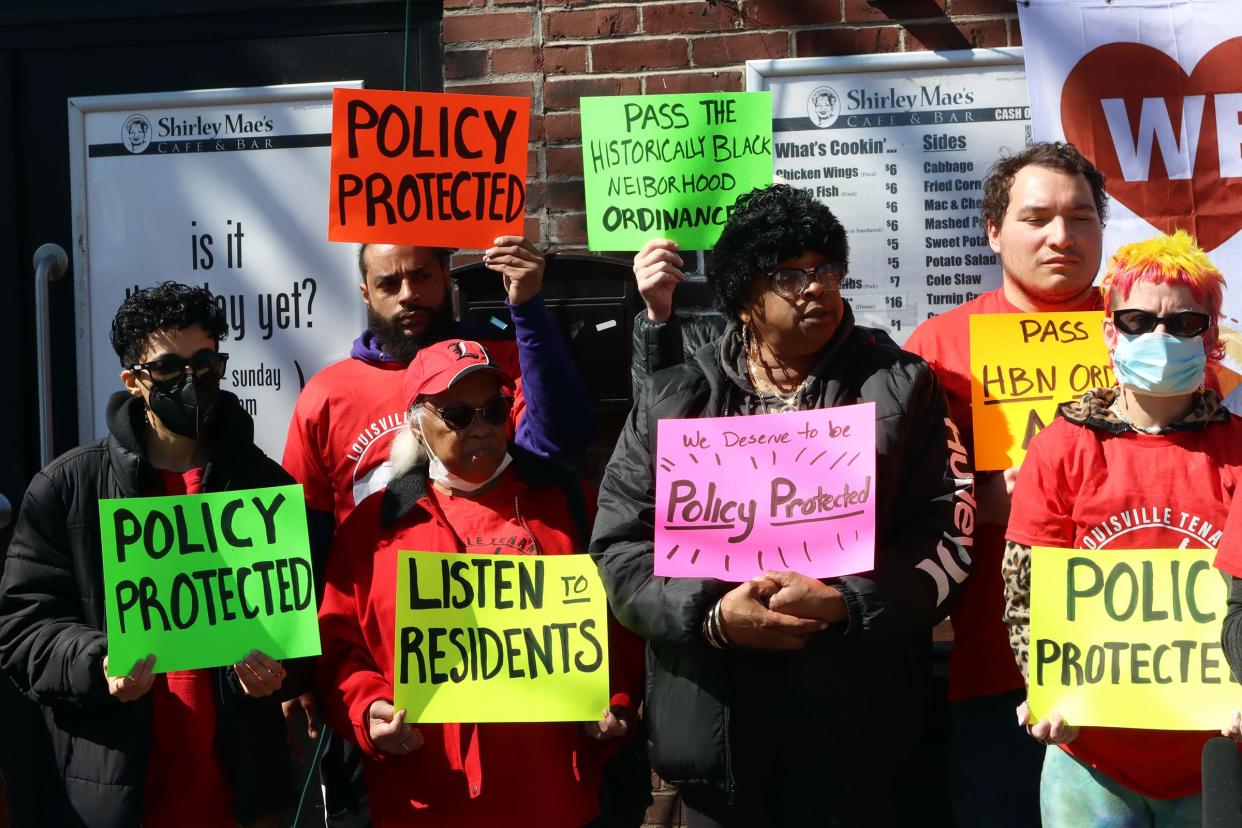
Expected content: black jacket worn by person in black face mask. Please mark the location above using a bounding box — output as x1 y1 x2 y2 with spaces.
0 392 330 828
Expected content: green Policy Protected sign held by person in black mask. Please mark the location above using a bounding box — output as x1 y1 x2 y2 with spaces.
99 485 319 675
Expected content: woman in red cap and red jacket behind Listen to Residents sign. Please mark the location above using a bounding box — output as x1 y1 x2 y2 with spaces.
318 339 642 828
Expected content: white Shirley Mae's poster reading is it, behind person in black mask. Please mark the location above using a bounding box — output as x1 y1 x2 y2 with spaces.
70 82 365 461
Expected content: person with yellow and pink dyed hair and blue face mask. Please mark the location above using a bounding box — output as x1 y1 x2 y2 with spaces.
1002 231 1242 826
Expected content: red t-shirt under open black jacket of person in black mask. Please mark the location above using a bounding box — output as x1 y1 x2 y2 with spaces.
143 468 237 828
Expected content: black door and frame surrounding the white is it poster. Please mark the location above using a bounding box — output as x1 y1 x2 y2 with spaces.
0 0 442 547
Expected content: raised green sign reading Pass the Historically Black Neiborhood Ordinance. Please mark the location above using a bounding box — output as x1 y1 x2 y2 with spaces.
580 92 773 251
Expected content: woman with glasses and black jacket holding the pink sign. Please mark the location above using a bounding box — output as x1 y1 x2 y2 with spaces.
591 185 974 828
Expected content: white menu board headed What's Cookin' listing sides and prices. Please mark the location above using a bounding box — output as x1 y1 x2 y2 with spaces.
746 48 1031 344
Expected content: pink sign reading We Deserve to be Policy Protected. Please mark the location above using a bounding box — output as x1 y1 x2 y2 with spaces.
656 402 876 581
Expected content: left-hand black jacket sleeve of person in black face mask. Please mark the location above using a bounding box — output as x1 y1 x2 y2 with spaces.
0 472 111 706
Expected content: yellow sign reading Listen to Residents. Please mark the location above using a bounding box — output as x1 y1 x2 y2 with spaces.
392 551 609 722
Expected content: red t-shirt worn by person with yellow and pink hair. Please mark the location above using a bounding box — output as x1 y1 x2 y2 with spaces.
1006 417 1242 799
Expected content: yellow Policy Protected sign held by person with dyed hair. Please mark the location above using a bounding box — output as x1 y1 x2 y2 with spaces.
1027 546 1242 730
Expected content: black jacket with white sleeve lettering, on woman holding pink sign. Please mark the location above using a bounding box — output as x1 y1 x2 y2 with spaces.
591 305 974 797
